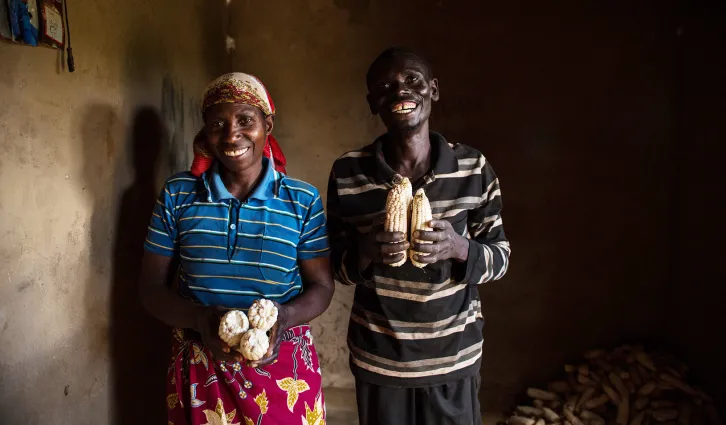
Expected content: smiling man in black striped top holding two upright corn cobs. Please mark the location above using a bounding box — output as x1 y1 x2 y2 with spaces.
328 48 510 425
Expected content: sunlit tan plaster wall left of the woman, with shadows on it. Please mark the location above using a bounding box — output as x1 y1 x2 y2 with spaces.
0 0 228 425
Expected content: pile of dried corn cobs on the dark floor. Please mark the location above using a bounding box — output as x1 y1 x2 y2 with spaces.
507 345 721 425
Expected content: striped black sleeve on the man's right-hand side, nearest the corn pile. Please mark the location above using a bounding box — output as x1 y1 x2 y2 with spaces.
454 156 511 284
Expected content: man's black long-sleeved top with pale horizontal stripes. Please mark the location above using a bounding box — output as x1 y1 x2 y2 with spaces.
328 133 510 386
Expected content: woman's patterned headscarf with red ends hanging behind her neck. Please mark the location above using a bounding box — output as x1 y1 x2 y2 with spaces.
191 72 287 176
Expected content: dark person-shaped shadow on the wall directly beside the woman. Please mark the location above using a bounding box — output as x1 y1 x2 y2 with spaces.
111 107 171 425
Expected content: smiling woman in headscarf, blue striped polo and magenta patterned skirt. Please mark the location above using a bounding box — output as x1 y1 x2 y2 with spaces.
140 73 334 425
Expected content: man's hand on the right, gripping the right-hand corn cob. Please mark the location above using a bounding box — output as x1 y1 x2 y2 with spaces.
412 220 469 264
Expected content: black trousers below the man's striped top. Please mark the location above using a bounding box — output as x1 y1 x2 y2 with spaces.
355 376 481 425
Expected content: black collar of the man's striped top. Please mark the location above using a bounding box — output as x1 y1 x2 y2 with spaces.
373 131 459 183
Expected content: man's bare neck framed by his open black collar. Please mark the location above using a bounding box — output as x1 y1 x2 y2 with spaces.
383 121 431 182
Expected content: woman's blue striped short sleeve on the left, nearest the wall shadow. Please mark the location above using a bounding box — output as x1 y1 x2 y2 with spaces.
144 184 178 257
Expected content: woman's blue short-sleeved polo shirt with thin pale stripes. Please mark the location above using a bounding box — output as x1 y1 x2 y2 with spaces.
144 158 329 309
